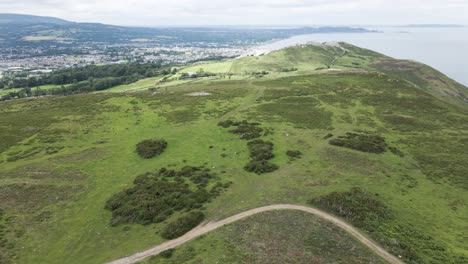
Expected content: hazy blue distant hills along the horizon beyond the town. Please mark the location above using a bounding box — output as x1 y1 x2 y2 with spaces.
0 14 369 46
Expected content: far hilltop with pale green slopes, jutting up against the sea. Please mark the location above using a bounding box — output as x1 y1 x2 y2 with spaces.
190 42 468 109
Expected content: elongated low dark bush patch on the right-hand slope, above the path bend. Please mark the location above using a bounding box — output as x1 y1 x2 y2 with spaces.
328 132 387 154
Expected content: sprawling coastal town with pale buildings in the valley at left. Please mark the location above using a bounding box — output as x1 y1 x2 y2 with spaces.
0 43 247 78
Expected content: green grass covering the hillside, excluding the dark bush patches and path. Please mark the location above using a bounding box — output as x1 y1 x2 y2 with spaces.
0 42 468 263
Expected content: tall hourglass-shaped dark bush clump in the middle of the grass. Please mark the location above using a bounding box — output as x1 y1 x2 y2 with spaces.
244 139 279 174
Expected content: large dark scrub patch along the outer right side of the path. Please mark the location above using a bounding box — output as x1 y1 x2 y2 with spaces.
309 188 458 264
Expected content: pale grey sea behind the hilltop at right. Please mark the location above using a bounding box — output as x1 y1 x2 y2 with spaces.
257 27 468 86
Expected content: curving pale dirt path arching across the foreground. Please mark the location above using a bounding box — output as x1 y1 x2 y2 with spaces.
109 204 403 264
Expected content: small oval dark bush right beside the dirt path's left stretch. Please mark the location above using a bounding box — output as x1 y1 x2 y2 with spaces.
161 211 205 239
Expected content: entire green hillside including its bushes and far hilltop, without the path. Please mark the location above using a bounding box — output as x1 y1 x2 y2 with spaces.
0 43 468 263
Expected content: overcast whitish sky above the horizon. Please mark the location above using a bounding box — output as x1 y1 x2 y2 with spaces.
0 0 468 26
